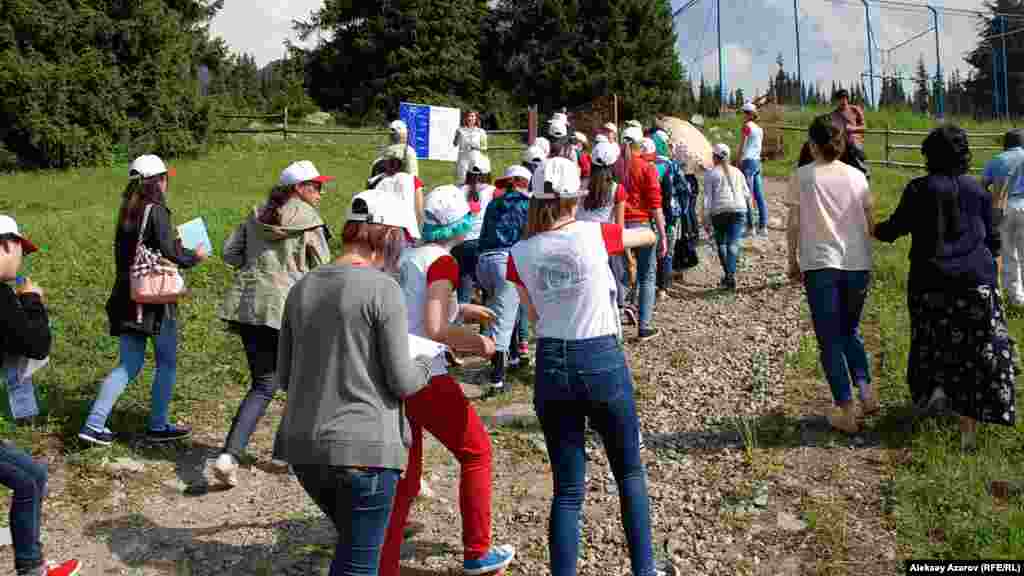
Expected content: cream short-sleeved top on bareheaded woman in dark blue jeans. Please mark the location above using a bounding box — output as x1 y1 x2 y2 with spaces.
786 161 871 272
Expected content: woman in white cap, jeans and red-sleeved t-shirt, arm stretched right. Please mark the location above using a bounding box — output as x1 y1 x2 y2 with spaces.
507 158 656 576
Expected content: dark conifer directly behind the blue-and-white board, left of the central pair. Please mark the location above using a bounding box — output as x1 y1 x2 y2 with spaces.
297 0 487 117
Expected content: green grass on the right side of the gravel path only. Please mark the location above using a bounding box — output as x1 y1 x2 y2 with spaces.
733 110 1024 559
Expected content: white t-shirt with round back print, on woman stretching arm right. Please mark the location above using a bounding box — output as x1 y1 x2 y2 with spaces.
507 221 624 340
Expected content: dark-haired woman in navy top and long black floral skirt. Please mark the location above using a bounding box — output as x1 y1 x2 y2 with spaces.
874 125 1016 450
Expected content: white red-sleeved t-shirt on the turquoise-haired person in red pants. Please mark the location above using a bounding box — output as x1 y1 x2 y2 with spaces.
398 244 459 376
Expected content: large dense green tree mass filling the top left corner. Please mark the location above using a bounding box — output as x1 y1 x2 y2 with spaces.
0 0 225 167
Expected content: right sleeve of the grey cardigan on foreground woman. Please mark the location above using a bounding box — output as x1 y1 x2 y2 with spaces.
376 279 430 398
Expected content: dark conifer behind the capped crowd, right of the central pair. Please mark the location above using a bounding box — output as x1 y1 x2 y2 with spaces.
480 0 689 118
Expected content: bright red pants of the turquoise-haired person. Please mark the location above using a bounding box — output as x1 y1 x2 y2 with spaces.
380 374 492 576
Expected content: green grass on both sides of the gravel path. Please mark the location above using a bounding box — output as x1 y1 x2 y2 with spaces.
0 111 1024 559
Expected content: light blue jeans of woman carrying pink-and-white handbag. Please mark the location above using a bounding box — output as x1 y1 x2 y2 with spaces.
85 315 178 430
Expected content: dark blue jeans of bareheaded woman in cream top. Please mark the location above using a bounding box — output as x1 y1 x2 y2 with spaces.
804 269 871 405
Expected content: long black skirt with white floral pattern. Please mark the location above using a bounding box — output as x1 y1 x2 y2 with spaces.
906 286 1016 426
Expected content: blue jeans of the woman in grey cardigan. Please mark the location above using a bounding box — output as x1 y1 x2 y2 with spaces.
293 464 401 576
